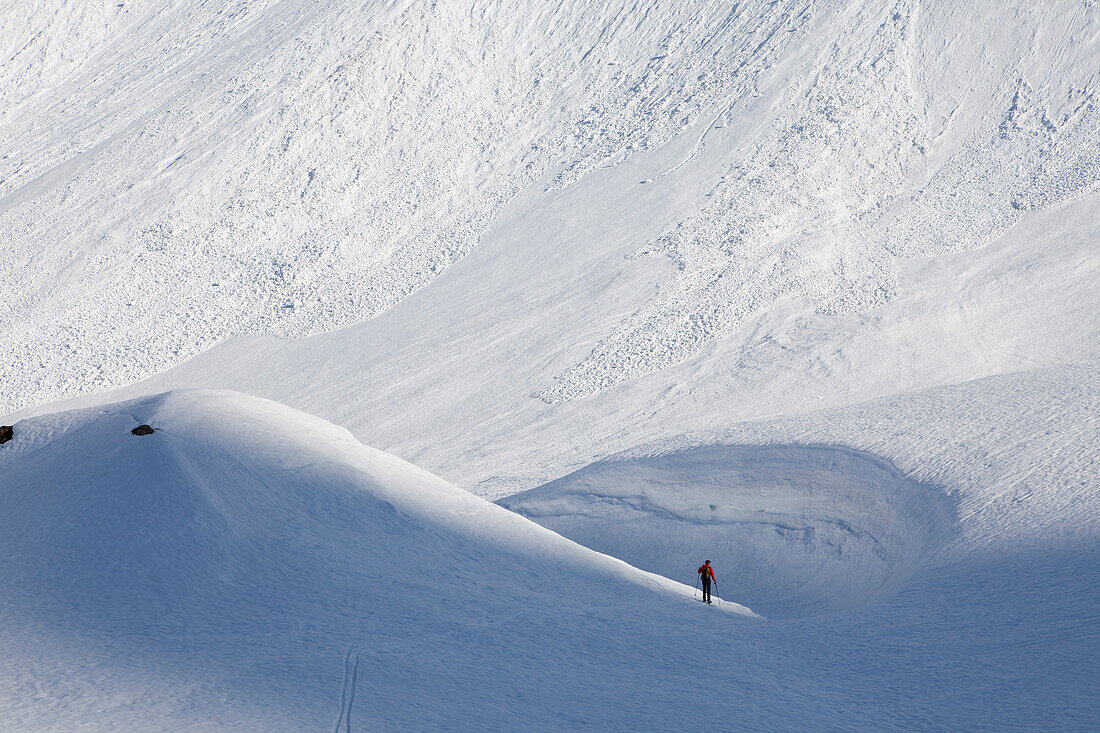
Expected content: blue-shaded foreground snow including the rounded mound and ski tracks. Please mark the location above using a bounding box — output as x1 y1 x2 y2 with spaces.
0 391 1098 731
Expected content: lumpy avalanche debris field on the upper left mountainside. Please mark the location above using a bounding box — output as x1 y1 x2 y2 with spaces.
0 0 805 408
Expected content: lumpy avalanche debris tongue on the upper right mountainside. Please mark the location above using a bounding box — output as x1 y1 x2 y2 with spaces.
540 1 1100 401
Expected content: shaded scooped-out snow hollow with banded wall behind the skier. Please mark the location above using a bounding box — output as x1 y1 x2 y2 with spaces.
499 446 954 619
